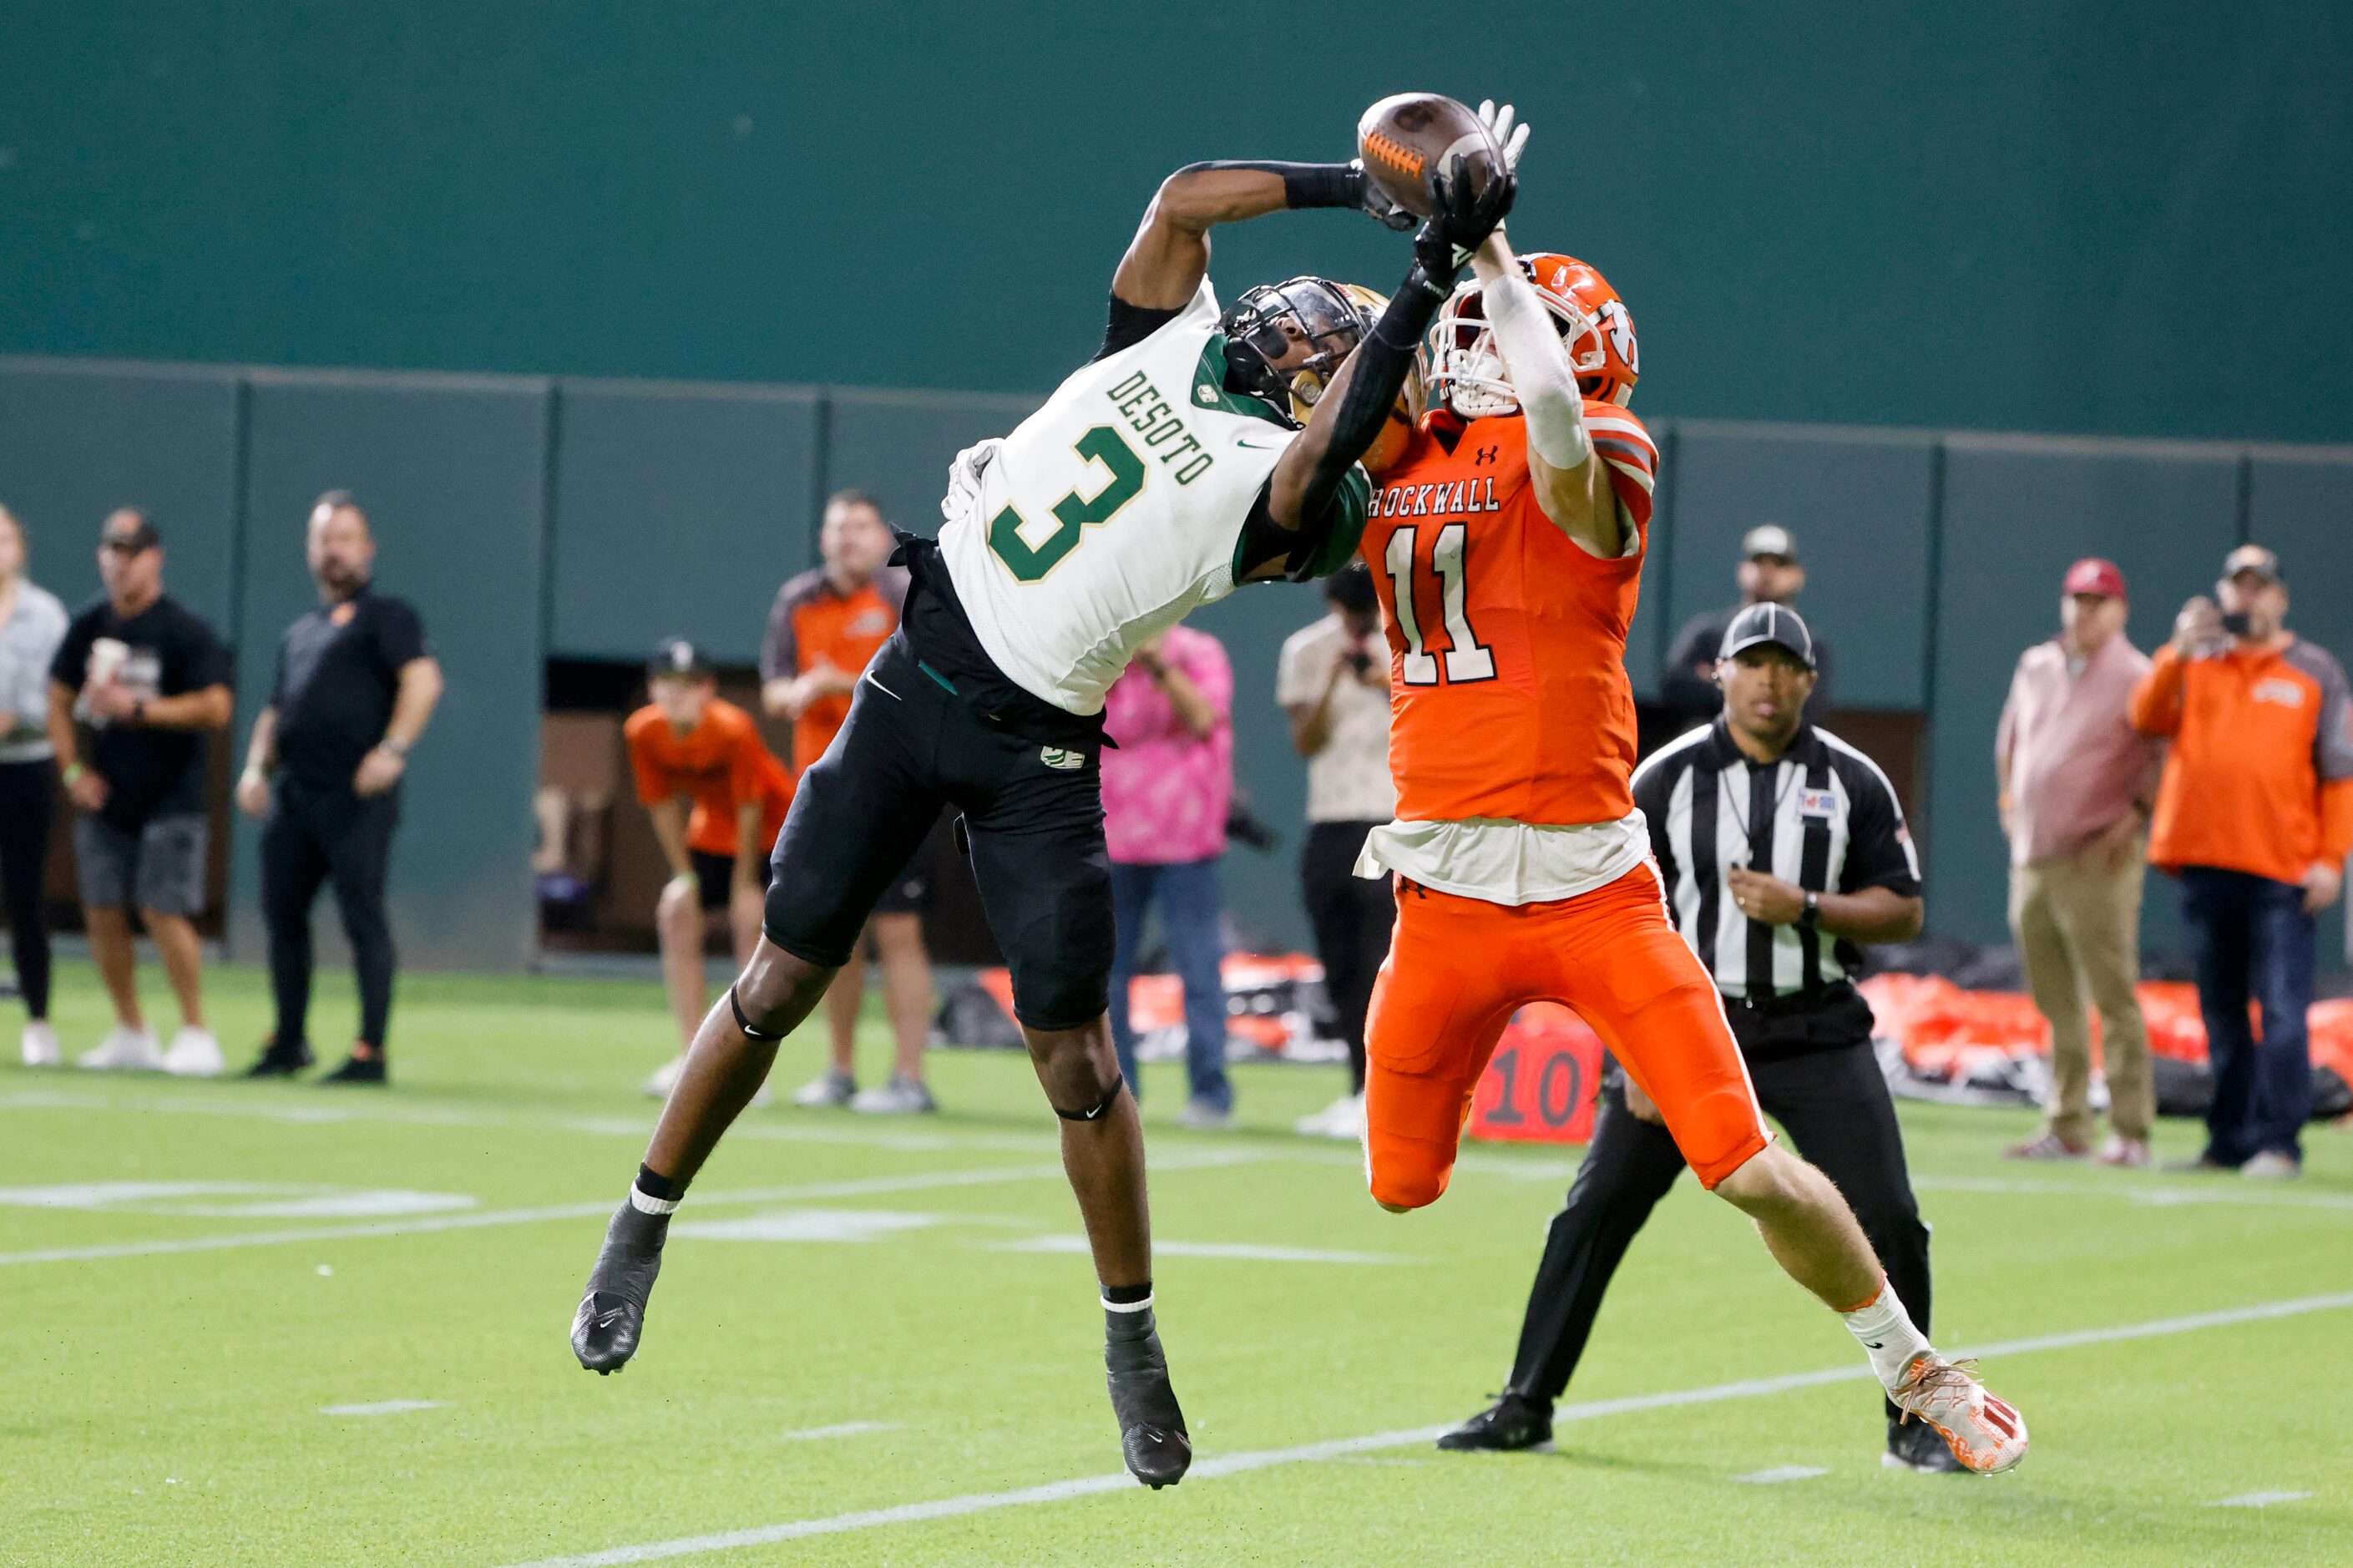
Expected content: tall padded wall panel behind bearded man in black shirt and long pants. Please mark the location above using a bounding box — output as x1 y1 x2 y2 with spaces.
228 372 549 969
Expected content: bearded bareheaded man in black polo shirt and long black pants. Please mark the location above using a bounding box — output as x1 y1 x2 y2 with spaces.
238 490 443 1083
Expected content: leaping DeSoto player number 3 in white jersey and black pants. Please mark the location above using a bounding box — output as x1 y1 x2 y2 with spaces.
572 131 1518 1488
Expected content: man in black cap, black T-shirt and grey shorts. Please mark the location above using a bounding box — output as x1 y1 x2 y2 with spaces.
49 506 235 1076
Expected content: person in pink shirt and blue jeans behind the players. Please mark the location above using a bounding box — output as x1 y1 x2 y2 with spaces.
1104 626 1233 1130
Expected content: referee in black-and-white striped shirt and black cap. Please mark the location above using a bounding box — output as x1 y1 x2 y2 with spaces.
1438 605 1960 1471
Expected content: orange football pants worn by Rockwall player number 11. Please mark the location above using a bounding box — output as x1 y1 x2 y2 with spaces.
1364 864 1772 1208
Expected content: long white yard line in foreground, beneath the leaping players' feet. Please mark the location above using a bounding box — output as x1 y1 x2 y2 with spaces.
491 1290 2353 1568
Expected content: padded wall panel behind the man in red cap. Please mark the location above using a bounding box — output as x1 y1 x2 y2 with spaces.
1927 436 2240 951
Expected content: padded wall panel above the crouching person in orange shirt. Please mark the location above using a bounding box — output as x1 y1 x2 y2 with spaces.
549 382 821 664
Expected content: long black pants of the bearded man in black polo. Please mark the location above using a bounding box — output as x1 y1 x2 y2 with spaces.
261 777 400 1052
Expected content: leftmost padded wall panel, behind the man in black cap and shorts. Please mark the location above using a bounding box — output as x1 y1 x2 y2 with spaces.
0 360 238 638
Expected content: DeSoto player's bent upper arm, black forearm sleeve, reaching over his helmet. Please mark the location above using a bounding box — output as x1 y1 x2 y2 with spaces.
1111 163 1412 311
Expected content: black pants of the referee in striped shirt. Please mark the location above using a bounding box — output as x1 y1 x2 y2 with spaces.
1508 1043 1930 1422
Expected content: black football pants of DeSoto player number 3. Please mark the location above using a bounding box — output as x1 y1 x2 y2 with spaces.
765 635 1113 1029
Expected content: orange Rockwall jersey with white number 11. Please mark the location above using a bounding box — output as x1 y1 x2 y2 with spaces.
1363 398 1659 824
